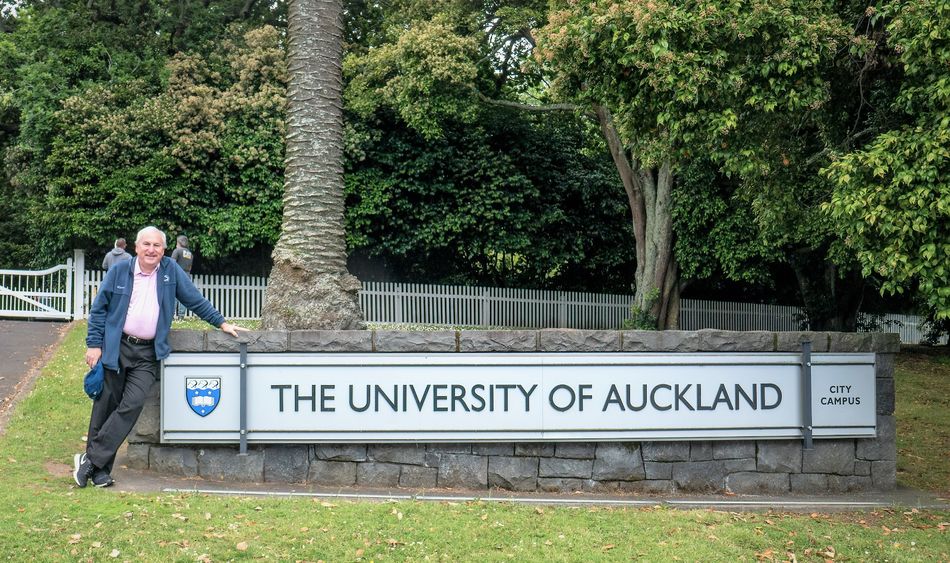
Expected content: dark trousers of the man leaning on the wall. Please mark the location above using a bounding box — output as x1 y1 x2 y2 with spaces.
86 339 158 473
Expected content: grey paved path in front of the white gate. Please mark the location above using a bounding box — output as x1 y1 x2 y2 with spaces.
0 319 67 429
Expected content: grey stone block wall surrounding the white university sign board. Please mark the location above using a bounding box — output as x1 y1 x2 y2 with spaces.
128 329 900 494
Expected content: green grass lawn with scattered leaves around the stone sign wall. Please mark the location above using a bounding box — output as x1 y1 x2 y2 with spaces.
0 324 950 561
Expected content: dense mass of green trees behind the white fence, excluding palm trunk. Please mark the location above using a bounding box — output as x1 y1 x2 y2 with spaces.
0 0 950 328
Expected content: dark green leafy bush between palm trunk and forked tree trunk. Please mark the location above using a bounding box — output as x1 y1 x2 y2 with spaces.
345 111 632 291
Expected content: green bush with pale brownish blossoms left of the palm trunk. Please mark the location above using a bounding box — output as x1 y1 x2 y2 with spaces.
31 27 286 264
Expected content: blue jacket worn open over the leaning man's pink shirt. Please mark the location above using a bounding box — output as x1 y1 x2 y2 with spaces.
86 256 224 371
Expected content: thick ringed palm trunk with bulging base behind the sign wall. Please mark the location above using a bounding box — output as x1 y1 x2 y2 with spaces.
261 0 363 329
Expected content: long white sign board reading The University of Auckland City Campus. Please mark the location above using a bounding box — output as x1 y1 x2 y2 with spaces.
161 353 876 443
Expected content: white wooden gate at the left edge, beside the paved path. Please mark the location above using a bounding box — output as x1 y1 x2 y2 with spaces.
0 251 85 320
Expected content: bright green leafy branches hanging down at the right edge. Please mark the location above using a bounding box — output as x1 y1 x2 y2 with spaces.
824 0 950 319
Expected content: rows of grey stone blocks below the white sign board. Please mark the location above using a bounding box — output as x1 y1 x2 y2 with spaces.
129 440 896 495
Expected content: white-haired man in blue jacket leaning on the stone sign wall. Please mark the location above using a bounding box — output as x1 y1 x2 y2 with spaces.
73 227 247 487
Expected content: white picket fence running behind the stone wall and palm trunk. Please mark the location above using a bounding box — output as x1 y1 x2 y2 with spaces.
78 271 940 344
